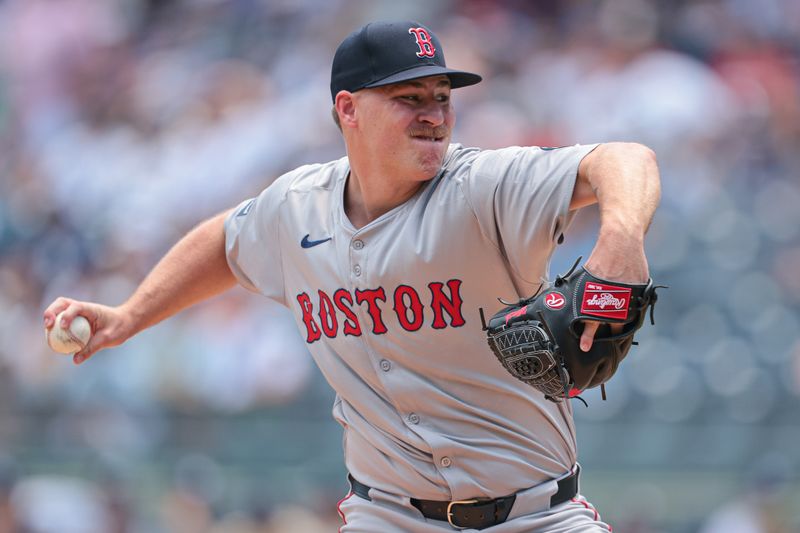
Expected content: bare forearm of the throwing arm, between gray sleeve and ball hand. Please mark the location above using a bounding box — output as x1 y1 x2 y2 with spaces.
120 212 236 334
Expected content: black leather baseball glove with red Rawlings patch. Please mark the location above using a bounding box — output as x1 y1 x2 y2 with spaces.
481 257 665 402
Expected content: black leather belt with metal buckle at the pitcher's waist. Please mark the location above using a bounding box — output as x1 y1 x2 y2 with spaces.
347 465 581 529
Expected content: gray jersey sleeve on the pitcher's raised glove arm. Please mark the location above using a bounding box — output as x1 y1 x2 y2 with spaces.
465 144 597 284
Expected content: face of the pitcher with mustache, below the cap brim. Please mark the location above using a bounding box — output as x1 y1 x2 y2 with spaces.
354 76 455 181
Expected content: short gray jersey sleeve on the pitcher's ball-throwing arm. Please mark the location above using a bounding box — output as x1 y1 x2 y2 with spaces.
225 182 285 304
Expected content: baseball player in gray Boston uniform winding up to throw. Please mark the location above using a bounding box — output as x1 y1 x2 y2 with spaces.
44 22 660 533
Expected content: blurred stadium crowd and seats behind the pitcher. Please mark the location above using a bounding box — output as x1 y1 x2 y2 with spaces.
0 0 800 533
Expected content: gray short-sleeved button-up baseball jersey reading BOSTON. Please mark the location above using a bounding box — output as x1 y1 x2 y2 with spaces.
226 144 594 500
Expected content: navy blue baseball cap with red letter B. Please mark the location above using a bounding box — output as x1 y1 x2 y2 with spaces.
331 21 481 100
